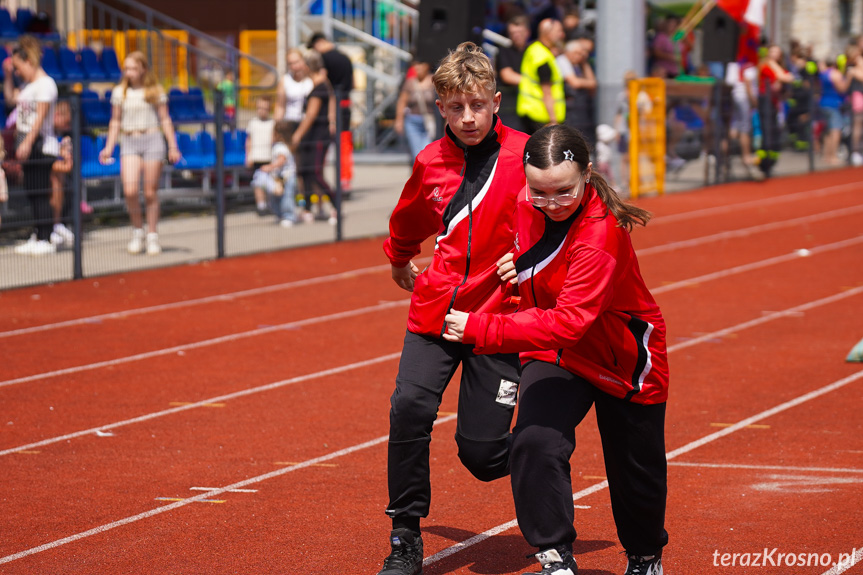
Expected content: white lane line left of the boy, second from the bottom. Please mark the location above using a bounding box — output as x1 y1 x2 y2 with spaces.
0 352 401 456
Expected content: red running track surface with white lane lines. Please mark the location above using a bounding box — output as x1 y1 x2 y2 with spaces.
0 170 863 575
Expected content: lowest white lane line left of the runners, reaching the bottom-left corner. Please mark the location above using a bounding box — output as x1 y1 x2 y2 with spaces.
0 415 456 565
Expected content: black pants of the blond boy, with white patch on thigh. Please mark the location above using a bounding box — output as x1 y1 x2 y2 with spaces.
386 332 519 525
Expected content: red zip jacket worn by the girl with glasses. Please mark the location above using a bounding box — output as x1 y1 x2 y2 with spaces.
464 185 668 404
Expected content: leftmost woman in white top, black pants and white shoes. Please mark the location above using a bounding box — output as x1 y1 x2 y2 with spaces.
3 36 60 255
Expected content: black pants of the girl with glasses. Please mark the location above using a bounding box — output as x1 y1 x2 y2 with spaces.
512 361 668 555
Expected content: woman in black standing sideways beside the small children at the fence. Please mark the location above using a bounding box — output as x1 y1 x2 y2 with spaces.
291 51 338 224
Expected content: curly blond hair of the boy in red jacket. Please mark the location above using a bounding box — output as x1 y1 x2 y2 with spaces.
432 42 497 99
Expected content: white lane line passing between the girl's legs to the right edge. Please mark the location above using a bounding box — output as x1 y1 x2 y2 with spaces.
423 371 863 575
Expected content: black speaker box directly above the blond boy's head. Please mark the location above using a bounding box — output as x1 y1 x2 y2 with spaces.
416 0 485 70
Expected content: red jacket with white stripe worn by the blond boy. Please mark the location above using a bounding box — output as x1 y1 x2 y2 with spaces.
384 117 527 337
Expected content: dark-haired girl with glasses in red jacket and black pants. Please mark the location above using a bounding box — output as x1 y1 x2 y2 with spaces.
444 125 668 575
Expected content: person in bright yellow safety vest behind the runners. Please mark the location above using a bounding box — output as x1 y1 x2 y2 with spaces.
516 18 566 134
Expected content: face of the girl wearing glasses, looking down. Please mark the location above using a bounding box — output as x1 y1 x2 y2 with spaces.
524 160 593 222
